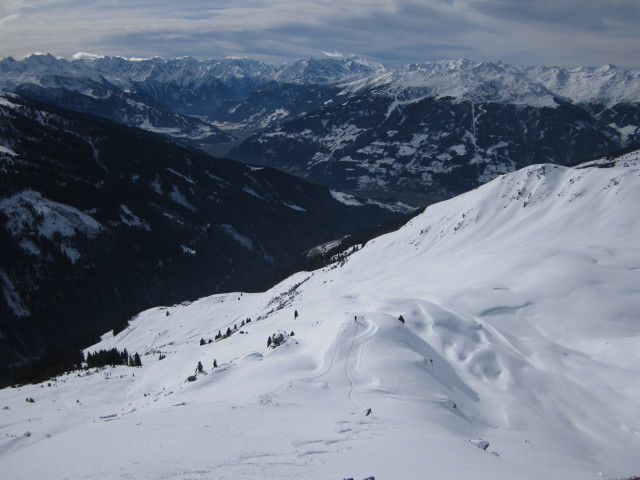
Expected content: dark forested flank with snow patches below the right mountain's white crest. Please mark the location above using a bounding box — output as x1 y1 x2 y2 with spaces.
229 90 640 200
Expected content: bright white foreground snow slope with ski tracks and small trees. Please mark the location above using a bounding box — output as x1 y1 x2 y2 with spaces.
0 153 640 480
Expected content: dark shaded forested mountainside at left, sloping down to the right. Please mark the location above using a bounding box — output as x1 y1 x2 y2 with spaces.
0 96 394 365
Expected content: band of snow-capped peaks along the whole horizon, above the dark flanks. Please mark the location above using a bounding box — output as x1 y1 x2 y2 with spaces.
0 54 640 106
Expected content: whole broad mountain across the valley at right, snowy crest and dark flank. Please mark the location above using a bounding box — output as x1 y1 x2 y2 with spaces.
216 60 640 203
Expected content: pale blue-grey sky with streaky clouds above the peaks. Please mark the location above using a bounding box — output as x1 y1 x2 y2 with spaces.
0 0 640 67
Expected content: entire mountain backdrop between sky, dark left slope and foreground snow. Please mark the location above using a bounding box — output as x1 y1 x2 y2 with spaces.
0 55 640 203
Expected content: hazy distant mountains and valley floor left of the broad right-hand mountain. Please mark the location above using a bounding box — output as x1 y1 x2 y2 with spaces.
0 54 380 147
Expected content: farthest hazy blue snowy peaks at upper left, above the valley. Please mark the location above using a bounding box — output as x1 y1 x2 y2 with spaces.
0 54 383 115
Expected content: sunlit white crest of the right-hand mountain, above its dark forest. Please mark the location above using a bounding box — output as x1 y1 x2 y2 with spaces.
347 60 640 107
